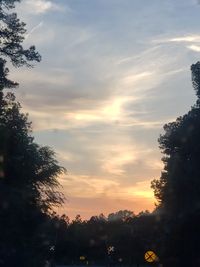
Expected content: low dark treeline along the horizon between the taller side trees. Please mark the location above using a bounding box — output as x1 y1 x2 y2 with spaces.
50 210 161 266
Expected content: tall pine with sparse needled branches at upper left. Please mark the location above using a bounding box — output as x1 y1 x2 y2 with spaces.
0 0 41 180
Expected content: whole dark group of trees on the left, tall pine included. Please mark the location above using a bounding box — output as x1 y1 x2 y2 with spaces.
0 0 65 267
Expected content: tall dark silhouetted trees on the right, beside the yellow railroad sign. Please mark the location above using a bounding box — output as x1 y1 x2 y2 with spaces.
152 62 200 266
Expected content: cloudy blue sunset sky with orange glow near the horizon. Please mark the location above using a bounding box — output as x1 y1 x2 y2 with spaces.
11 0 200 219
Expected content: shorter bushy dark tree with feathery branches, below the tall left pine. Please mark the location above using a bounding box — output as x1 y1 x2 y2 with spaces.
0 93 65 266
